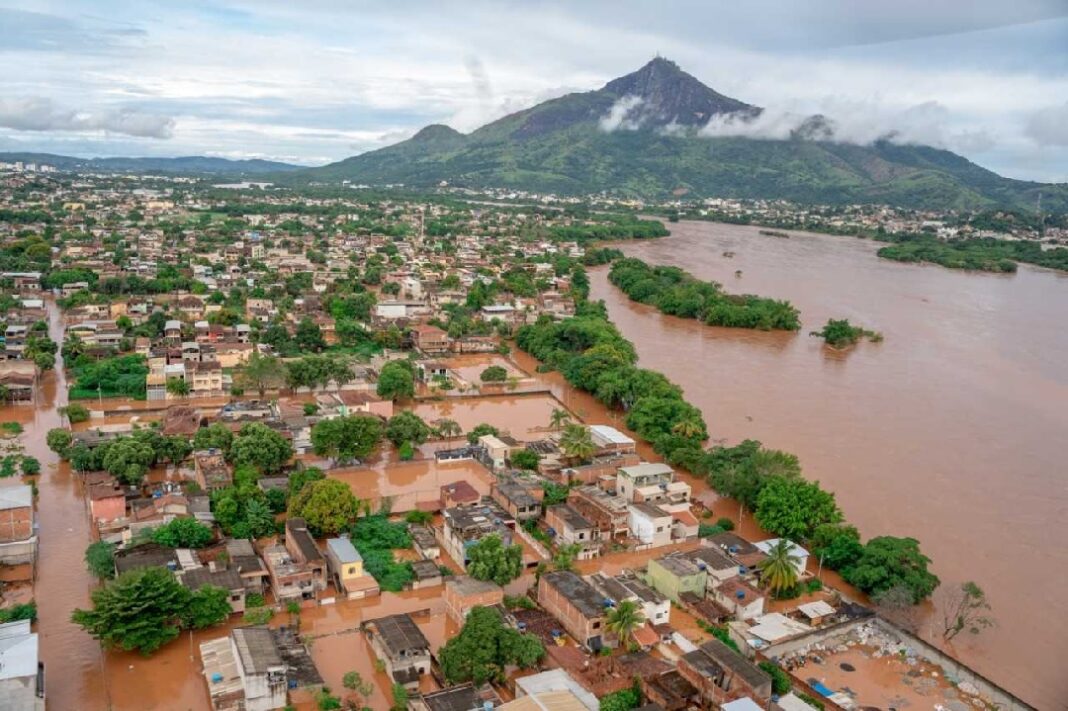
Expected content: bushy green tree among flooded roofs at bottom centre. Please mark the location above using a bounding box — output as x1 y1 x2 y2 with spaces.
438 606 545 686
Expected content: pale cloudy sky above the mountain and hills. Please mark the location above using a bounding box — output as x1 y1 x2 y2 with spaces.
0 0 1068 181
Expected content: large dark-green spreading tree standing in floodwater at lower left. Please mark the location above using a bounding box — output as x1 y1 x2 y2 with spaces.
70 568 190 655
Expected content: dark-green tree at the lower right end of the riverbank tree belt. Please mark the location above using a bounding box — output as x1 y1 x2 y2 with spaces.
842 536 940 603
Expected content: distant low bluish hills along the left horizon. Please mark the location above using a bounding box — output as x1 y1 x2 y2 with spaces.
0 153 302 175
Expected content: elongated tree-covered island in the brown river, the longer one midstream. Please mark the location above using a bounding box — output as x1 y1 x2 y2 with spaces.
609 257 801 331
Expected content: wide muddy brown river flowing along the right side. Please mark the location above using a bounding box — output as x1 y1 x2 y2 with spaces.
591 222 1068 708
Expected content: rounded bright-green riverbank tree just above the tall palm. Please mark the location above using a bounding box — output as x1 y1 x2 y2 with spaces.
754 477 842 540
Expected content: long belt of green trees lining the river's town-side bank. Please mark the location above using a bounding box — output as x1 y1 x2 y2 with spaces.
516 268 939 603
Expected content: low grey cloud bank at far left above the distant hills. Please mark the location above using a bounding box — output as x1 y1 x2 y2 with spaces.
0 96 174 139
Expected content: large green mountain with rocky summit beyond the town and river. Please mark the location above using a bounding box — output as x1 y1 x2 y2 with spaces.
301 57 1068 211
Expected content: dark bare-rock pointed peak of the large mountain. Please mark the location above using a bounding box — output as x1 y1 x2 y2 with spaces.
601 56 760 126
